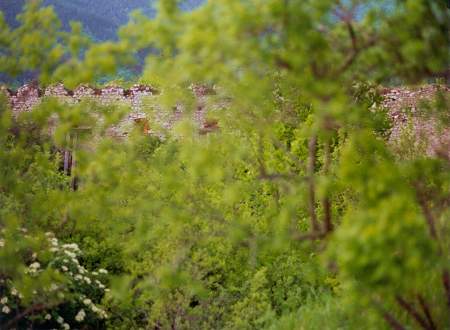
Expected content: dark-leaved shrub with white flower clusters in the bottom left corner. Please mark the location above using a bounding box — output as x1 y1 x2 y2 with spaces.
0 233 109 329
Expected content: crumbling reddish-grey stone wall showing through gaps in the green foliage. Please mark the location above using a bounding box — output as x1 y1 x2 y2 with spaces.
0 84 450 160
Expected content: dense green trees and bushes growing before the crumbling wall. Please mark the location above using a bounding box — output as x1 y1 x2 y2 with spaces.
0 0 450 329
